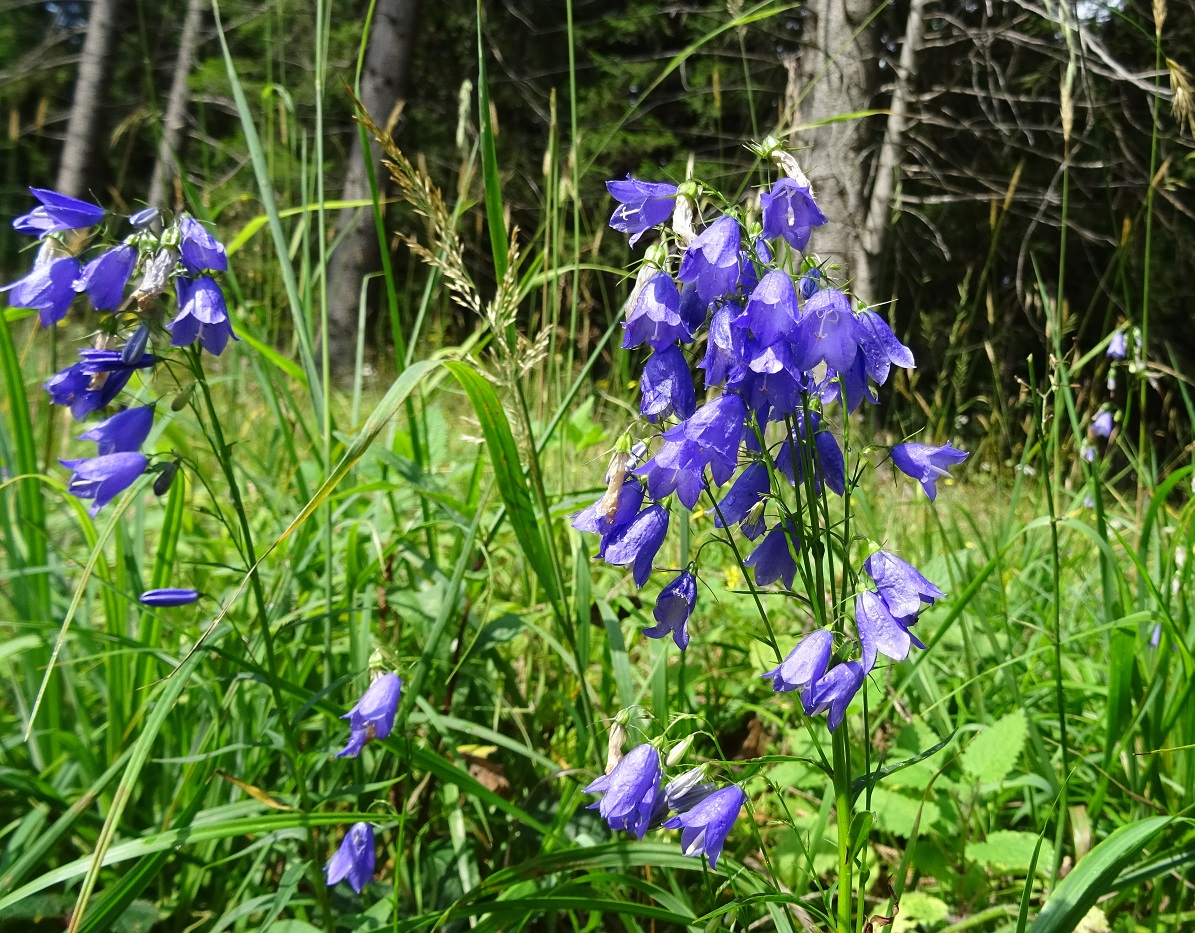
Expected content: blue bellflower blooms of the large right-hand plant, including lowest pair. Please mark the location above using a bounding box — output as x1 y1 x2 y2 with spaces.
574 140 967 864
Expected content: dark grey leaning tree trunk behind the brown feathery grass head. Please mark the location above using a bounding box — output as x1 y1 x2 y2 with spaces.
327 0 418 373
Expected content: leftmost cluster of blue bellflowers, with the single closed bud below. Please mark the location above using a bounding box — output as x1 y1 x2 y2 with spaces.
0 188 237 607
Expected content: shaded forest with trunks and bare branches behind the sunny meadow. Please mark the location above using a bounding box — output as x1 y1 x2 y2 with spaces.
0 0 1195 458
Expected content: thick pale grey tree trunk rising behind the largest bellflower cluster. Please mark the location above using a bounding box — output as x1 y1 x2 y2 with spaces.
791 0 878 300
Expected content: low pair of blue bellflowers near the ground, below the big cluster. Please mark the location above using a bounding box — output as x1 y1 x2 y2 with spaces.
586 744 747 868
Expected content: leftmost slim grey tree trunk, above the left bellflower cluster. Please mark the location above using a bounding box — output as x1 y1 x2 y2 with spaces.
56 0 127 197
